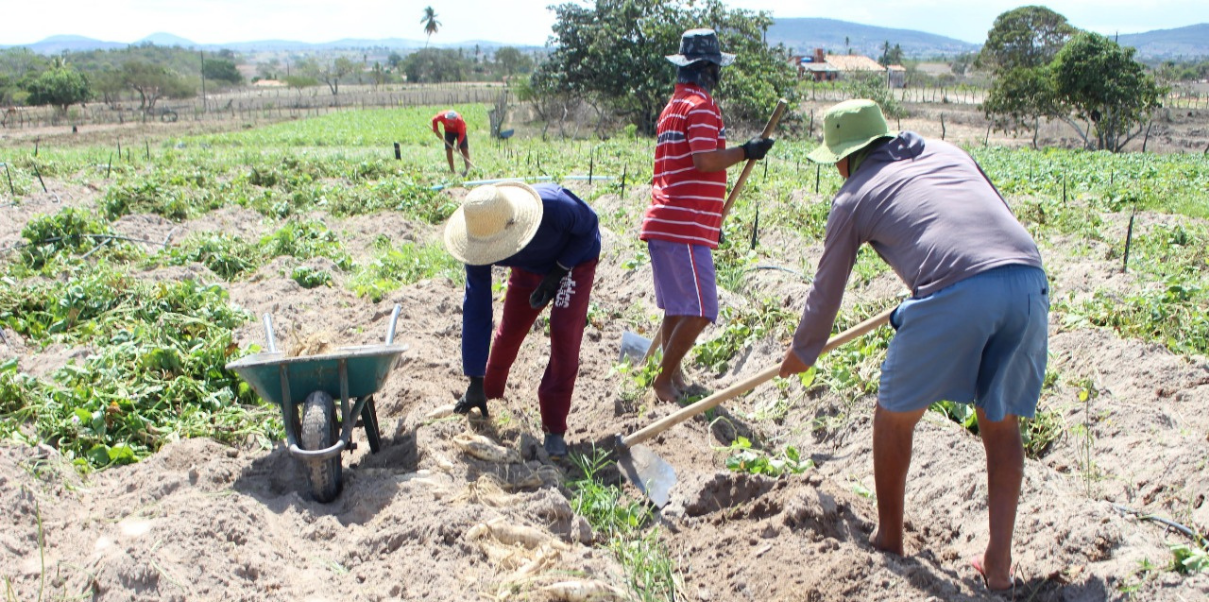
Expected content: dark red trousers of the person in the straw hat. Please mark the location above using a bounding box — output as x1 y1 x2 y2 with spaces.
482 260 596 435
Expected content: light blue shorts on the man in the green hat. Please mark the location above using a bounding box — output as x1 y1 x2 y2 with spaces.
878 265 1049 422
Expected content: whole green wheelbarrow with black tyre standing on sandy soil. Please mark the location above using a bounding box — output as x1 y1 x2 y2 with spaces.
226 306 407 503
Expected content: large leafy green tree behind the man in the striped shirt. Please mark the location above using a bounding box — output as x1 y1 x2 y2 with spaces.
527 0 796 133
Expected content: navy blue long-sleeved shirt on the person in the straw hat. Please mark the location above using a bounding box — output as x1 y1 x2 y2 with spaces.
462 184 601 376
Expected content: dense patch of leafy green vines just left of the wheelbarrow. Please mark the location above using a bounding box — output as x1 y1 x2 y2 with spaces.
0 268 280 468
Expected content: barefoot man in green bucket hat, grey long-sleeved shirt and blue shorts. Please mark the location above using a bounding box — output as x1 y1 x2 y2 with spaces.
780 100 1049 590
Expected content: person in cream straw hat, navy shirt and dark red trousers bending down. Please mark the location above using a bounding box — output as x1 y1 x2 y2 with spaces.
445 183 601 457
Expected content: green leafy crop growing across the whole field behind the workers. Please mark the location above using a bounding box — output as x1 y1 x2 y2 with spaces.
0 105 1209 468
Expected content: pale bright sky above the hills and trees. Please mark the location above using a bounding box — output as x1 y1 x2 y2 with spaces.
0 0 1209 45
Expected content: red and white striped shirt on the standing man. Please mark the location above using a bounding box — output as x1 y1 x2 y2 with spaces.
640 83 727 249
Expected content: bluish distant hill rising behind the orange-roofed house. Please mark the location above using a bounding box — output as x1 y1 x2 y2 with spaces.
767 18 979 58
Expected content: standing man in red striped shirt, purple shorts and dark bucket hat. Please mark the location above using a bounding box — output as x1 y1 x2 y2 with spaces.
640 29 773 401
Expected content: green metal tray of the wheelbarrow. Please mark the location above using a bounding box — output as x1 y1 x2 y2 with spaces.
226 345 407 410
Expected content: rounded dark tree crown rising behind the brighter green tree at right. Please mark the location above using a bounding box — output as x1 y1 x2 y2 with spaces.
974 6 1078 75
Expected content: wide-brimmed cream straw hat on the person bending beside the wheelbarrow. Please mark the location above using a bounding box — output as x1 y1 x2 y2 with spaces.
445 181 542 266
